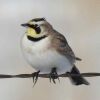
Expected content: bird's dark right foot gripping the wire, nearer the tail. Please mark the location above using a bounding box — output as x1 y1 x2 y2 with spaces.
49 67 60 84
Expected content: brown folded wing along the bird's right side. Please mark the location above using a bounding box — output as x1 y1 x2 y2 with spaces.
52 32 78 62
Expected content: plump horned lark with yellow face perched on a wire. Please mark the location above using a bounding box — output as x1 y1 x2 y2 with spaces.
21 18 89 86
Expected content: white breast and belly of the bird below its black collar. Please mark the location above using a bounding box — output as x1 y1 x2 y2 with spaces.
22 34 72 74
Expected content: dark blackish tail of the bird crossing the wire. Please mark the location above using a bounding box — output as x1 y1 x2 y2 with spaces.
70 65 89 85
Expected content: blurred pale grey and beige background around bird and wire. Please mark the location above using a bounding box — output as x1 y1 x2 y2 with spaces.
0 0 100 100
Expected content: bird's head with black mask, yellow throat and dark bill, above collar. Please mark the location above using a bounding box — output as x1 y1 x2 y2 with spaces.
21 18 52 38
